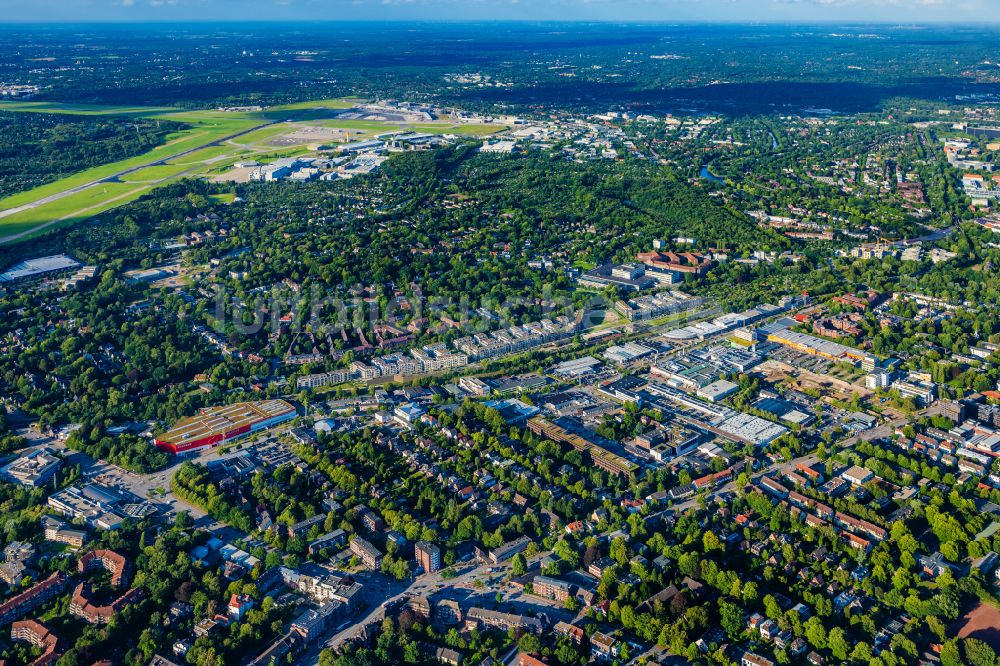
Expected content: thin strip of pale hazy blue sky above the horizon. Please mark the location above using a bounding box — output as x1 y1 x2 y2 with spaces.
0 0 988 25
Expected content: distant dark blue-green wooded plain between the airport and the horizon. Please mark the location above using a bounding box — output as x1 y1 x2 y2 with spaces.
0 23 997 114
